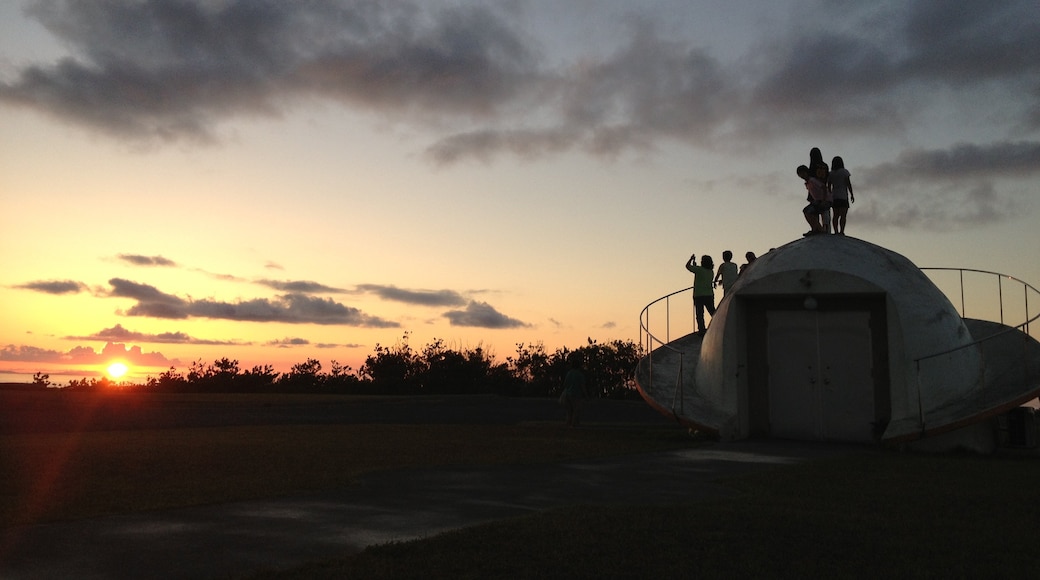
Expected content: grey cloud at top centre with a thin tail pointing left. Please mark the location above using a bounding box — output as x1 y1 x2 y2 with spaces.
427 23 737 163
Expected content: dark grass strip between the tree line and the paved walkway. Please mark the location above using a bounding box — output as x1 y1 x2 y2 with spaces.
0 424 690 525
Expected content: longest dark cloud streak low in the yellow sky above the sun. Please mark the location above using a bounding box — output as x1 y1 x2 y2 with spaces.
108 278 399 328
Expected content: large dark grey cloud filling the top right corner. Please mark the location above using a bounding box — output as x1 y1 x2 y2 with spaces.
743 0 1040 133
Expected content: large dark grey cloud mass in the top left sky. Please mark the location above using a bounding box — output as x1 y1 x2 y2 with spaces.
0 0 532 141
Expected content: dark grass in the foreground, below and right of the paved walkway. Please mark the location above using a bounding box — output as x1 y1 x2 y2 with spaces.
252 453 1040 580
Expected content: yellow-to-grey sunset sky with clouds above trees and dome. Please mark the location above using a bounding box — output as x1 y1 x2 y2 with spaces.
0 0 1040 380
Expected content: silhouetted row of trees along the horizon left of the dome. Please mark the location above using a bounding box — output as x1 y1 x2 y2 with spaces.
40 333 643 398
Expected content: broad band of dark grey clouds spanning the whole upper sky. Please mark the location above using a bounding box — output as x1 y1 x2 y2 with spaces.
0 0 1040 166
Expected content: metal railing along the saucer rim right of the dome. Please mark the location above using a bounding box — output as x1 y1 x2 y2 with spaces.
914 268 1040 431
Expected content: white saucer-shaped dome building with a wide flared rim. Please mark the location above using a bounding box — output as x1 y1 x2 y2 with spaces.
636 236 1040 448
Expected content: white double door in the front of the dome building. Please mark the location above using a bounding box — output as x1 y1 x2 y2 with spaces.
766 311 875 442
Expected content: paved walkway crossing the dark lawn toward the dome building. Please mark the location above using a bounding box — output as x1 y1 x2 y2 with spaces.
0 442 861 580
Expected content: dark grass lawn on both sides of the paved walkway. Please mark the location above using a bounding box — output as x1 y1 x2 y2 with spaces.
6 390 1040 579
